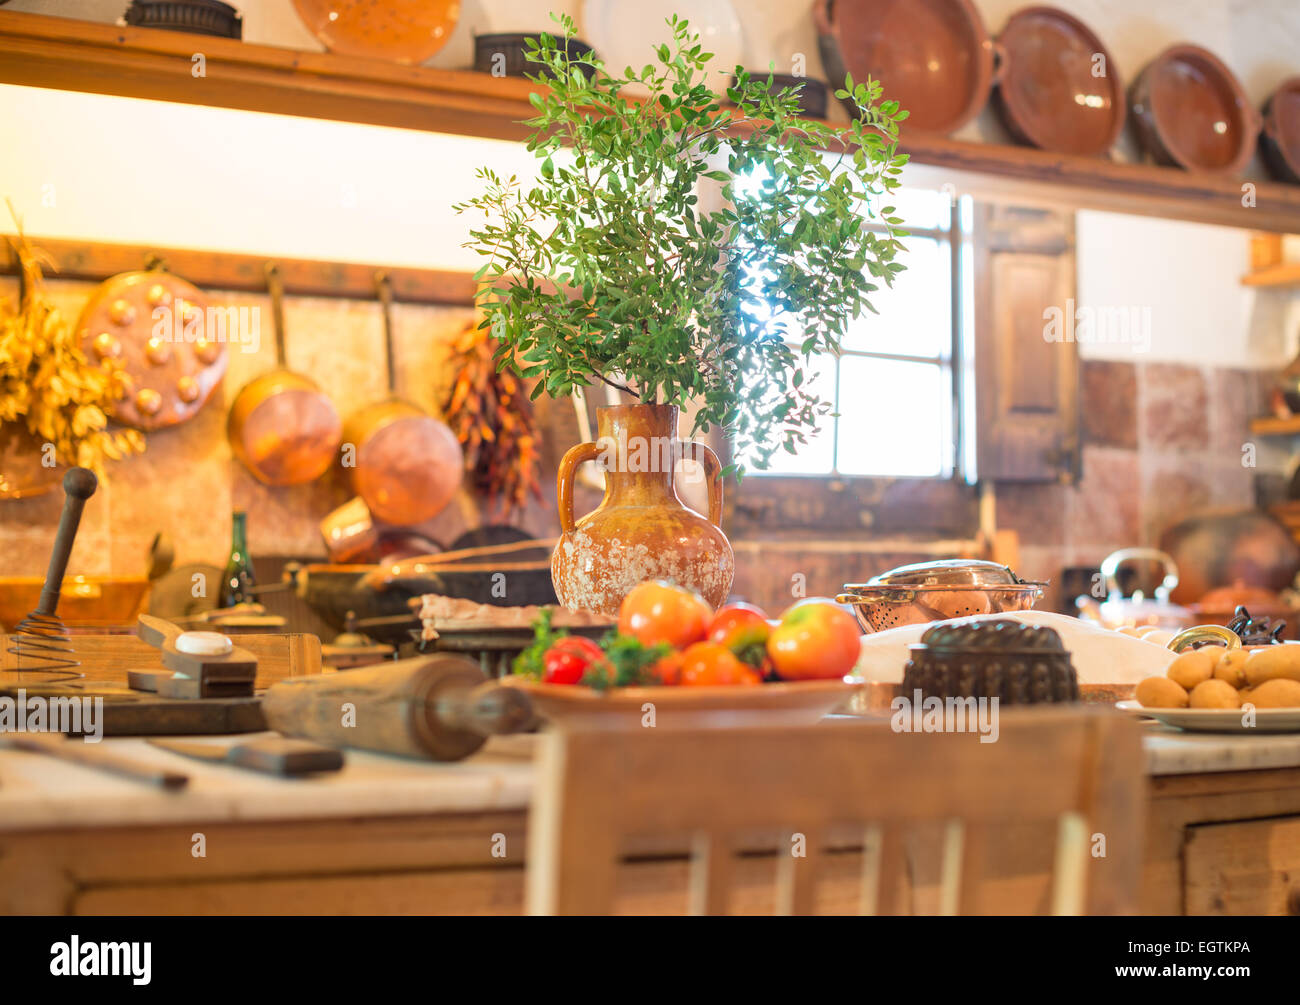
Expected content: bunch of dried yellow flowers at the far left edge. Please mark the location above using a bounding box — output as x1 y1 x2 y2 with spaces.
0 228 144 477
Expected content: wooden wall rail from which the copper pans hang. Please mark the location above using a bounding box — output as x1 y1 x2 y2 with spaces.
0 235 477 307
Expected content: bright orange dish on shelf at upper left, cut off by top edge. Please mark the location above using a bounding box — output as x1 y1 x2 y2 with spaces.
294 0 460 64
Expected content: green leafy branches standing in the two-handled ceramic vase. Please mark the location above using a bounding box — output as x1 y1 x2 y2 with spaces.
456 16 907 467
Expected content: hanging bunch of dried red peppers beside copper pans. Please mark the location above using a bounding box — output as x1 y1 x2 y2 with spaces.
443 325 542 515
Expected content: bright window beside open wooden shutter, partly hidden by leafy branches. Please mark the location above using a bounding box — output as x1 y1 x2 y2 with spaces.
749 189 969 478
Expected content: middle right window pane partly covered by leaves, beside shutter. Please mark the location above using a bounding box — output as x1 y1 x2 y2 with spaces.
841 238 953 358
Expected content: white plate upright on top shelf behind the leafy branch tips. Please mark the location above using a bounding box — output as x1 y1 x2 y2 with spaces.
582 0 745 83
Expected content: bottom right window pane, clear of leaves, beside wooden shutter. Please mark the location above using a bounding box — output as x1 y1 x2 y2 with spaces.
837 356 952 477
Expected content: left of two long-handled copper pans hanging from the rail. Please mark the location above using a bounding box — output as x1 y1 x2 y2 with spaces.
226 263 343 485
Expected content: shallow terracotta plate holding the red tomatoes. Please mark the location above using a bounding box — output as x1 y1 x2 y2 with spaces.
503 677 862 729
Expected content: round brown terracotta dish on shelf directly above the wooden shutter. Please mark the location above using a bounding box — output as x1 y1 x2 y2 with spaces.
995 7 1125 157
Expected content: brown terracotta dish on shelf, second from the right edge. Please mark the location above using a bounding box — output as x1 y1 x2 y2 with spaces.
1128 46 1260 176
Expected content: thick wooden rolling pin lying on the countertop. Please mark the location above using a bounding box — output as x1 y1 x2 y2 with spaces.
261 653 534 761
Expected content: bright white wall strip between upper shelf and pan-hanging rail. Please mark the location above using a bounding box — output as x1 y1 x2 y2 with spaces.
0 85 534 270
